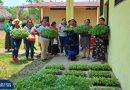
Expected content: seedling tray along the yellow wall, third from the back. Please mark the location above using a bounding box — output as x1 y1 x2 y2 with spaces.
92 78 120 86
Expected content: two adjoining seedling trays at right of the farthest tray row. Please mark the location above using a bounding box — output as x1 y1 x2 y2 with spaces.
69 64 112 71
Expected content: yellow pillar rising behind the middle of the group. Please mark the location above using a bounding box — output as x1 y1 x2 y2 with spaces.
66 0 74 20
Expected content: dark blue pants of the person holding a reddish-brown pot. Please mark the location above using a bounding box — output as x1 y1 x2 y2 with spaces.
25 40 35 58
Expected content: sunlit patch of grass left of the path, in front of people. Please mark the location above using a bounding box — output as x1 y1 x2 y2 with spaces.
0 54 29 79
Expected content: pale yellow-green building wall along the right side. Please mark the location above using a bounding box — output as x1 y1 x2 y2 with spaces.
100 0 130 90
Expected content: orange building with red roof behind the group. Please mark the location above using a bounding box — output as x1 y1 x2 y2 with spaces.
19 0 99 25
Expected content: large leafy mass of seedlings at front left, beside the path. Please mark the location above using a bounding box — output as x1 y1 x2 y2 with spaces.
14 72 57 90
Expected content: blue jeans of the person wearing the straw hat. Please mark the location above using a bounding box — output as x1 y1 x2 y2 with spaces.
11 38 22 58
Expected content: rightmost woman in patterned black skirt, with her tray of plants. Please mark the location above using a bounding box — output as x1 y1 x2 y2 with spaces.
92 17 109 62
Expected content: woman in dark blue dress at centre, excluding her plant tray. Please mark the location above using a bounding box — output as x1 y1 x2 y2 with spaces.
65 19 79 60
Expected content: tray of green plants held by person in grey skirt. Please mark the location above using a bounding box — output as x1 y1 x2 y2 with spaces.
74 25 92 34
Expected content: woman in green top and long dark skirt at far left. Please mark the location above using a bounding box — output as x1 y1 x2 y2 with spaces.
4 19 13 52
